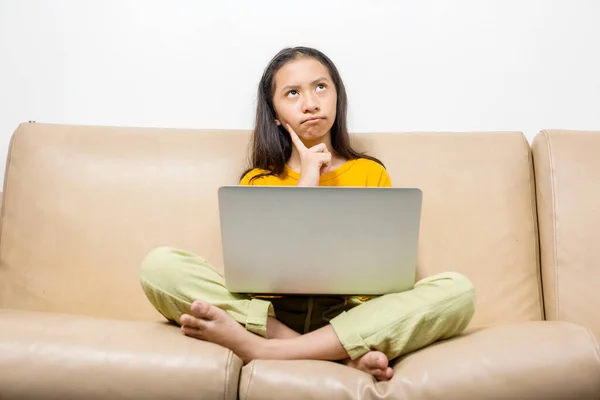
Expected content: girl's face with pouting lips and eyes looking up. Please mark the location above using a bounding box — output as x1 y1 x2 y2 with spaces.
273 57 337 142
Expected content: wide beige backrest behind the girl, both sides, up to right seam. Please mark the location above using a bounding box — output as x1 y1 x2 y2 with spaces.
0 123 542 326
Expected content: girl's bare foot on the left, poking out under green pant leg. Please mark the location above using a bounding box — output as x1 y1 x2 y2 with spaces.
179 301 266 363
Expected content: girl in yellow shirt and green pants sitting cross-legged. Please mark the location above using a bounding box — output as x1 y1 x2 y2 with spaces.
141 47 475 380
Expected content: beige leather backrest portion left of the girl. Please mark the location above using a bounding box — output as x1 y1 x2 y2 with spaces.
0 123 248 321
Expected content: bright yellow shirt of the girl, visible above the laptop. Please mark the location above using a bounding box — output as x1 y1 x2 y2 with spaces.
240 158 392 187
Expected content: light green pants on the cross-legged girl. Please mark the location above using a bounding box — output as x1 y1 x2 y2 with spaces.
141 247 475 360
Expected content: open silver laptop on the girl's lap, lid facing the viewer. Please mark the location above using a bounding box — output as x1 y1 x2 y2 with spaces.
218 186 422 296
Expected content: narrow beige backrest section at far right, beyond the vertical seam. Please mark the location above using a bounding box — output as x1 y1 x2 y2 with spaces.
532 130 600 337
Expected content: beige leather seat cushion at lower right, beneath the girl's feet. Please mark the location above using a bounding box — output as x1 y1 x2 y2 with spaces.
240 321 600 400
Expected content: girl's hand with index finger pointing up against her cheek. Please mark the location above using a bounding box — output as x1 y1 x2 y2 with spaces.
287 124 331 186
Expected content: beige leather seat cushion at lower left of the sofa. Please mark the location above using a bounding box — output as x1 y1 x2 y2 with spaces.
0 310 242 399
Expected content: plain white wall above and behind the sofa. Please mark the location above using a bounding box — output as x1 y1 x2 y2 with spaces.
0 0 600 186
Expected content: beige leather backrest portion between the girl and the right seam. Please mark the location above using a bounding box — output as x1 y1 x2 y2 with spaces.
356 132 543 326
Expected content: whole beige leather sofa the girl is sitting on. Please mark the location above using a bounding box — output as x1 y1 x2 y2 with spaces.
0 123 600 400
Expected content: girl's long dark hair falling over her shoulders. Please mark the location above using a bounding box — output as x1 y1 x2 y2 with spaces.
240 47 383 179
